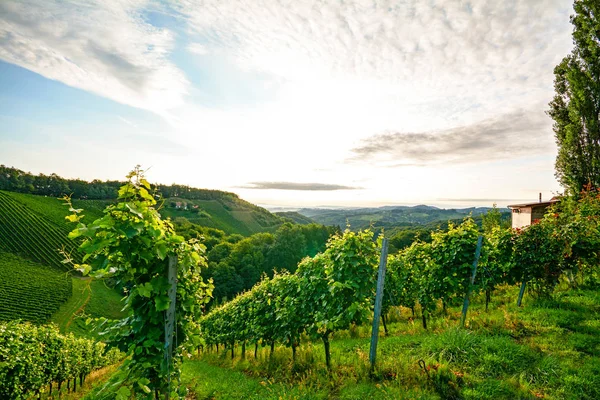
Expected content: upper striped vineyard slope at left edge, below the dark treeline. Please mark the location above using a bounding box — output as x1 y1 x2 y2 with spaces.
0 191 81 270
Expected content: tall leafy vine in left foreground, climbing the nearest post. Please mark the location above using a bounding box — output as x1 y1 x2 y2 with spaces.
66 167 210 397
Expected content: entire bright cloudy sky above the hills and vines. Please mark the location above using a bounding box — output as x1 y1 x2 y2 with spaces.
0 0 573 207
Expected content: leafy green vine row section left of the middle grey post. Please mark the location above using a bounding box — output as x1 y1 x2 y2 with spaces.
200 230 377 366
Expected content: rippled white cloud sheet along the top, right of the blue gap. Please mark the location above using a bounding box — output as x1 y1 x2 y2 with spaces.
176 0 572 88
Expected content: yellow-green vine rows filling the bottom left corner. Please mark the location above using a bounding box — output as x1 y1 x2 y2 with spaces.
0 322 122 399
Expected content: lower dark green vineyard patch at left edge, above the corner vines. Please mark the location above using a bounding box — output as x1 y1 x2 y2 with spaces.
0 252 73 323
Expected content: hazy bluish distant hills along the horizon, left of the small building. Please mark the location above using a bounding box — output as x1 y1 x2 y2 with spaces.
298 205 508 229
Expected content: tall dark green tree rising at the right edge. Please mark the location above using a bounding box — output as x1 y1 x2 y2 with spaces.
548 0 600 194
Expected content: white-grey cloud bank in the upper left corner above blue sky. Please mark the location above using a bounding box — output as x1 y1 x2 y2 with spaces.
0 0 188 113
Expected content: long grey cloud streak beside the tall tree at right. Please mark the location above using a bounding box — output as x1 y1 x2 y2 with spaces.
347 110 553 167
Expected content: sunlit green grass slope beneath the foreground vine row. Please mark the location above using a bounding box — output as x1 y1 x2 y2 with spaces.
184 288 600 399
